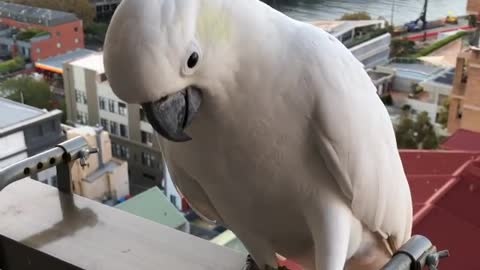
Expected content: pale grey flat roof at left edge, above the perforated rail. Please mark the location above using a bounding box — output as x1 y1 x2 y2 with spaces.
0 98 46 131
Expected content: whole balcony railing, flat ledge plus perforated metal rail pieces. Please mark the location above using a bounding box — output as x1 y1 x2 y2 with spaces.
0 137 447 270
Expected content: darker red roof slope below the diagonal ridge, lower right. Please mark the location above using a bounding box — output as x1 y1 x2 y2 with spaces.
413 158 480 270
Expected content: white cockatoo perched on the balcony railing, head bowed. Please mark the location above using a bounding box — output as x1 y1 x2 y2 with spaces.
104 0 412 270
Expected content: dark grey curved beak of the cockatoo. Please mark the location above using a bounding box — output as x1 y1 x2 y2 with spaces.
142 86 202 142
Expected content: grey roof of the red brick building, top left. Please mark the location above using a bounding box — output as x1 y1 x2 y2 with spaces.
0 1 78 26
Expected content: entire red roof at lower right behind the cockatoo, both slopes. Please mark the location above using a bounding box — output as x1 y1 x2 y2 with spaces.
281 148 480 270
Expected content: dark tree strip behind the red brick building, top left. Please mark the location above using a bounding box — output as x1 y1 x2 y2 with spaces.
8 0 96 25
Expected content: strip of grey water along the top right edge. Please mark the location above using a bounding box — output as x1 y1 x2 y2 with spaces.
264 0 467 25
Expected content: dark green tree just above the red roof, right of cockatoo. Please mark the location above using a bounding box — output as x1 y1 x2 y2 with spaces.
395 112 439 149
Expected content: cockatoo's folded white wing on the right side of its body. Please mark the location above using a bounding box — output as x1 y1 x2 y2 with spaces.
303 27 412 248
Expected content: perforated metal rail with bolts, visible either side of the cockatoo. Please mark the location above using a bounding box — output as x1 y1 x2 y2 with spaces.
0 137 449 270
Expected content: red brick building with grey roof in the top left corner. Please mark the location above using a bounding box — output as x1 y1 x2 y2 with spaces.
0 1 85 62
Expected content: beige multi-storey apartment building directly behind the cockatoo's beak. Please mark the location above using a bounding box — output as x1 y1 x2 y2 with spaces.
63 53 165 195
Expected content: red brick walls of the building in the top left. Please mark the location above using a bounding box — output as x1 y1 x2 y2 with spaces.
0 18 85 62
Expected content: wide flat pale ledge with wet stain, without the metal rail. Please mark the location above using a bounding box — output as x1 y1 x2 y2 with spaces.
0 180 246 270
